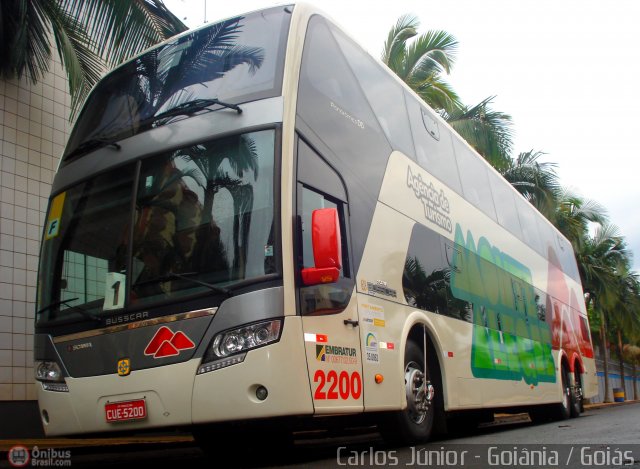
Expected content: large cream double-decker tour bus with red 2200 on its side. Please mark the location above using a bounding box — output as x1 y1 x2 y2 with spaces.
34 4 597 444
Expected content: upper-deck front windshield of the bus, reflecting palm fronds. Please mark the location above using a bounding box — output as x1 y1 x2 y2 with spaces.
62 7 290 165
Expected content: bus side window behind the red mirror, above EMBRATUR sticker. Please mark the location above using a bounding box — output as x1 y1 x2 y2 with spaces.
298 184 353 315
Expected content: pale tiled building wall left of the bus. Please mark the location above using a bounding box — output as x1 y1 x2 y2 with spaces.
0 53 70 401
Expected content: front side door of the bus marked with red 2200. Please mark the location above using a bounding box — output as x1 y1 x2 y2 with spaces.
296 140 363 414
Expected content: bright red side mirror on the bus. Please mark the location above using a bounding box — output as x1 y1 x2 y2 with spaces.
302 208 342 285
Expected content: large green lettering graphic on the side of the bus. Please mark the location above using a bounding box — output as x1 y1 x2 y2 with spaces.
451 224 556 385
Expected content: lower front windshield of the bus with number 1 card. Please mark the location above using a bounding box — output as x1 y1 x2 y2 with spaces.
36 130 277 324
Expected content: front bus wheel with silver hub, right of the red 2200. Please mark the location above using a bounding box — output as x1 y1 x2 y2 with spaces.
379 341 443 445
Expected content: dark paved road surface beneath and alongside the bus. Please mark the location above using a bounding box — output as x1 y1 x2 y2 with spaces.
0 403 640 469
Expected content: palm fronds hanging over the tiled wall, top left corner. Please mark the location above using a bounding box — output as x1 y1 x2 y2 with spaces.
0 0 187 116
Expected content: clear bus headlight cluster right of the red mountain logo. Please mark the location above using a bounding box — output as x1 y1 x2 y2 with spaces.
198 319 282 374
